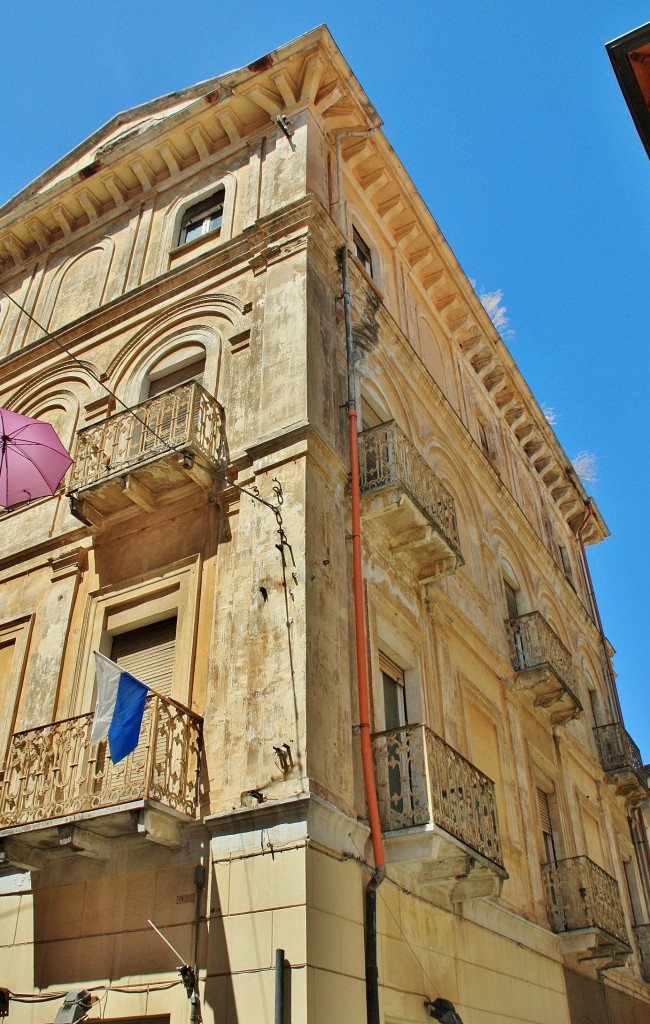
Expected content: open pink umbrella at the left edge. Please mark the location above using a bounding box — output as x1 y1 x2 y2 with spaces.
0 409 73 508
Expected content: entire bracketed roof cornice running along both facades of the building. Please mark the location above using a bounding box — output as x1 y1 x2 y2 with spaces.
0 28 607 543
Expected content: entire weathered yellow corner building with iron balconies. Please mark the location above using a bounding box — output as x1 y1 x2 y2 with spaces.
0 29 650 1024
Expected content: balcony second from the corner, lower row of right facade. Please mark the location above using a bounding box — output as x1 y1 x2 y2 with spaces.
543 857 632 971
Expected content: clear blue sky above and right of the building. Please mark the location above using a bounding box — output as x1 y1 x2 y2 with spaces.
0 0 650 761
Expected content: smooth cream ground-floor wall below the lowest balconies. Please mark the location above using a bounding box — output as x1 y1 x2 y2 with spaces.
5 796 650 1024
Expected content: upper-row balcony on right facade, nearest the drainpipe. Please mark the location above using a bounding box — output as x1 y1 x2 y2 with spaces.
359 421 463 583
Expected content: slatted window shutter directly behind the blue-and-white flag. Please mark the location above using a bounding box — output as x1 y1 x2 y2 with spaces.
111 616 176 697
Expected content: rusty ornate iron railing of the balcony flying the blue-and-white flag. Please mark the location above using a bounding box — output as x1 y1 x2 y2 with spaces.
0 693 203 828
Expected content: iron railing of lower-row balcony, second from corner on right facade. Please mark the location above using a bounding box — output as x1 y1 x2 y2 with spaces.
541 857 629 945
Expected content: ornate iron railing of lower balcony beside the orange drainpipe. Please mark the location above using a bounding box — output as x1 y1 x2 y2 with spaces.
373 725 504 867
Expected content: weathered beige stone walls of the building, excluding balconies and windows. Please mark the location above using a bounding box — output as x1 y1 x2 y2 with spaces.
0 33 647 1024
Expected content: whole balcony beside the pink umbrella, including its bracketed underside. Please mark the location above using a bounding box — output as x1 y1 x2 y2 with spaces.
68 381 224 526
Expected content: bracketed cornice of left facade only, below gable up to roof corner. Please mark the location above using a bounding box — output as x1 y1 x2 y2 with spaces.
0 27 381 274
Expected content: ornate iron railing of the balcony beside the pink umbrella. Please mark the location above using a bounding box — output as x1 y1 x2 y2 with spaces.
68 381 224 493
